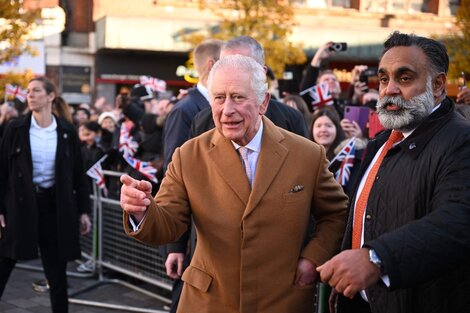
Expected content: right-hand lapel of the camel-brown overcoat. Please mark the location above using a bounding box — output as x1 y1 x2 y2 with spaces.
243 117 289 218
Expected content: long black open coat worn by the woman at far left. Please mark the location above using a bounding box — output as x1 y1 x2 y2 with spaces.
0 113 91 261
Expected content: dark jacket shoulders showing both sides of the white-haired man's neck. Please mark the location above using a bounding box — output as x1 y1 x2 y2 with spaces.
191 99 309 138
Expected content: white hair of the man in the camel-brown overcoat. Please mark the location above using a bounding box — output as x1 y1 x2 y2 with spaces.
207 54 268 105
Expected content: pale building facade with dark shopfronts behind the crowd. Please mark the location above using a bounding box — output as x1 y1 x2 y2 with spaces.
24 0 459 104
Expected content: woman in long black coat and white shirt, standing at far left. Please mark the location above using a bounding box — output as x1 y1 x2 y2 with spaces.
0 77 91 313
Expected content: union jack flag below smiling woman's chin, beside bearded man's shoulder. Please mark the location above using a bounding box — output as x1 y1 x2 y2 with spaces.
329 137 356 186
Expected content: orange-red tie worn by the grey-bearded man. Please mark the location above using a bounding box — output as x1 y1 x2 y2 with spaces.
352 130 403 249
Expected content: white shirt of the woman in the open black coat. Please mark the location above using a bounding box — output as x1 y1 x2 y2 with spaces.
29 115 57 188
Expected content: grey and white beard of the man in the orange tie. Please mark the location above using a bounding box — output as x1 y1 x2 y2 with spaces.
377 78 434 132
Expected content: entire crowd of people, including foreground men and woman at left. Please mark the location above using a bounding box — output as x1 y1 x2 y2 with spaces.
0 32 470 313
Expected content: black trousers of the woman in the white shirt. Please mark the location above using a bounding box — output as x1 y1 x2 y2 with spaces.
0 189 68 313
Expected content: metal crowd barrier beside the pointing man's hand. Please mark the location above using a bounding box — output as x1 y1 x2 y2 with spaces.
69 171 172 313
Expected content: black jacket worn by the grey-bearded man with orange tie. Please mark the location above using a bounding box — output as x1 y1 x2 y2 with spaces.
338 99 470 313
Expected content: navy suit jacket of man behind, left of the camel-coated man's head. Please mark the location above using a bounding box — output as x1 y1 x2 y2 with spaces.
163 88 209 170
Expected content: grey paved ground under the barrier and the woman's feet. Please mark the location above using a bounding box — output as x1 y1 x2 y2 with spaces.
0 261 173 313
